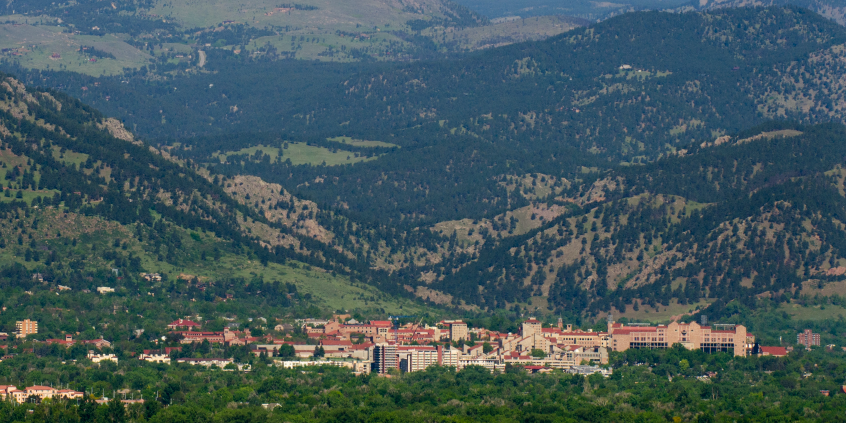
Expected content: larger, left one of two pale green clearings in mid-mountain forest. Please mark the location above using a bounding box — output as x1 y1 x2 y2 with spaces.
215 143 376 166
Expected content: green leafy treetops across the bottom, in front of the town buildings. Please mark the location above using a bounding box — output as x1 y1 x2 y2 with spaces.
0 346 846 423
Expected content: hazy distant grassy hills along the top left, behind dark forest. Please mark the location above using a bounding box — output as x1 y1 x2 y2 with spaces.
0 0 584 77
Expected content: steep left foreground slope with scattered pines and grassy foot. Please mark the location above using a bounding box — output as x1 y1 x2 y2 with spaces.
0 75 430 316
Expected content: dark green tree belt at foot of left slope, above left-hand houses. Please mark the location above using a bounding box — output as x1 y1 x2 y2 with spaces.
0 256 318 346
